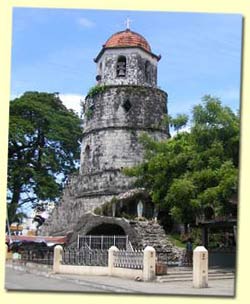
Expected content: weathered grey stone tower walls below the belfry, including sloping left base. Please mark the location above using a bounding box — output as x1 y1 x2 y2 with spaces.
40 86 168 235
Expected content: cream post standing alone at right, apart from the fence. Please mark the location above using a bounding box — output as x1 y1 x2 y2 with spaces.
193 246 208 288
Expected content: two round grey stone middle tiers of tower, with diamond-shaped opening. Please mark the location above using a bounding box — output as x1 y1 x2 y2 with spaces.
80 86 168 174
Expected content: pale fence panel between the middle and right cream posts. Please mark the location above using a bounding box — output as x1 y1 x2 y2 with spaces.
114 250 143 269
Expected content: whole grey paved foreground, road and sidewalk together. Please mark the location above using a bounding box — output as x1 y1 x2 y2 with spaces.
5 265 234 297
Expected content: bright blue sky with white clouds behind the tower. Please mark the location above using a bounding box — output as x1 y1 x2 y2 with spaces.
11 8 242 116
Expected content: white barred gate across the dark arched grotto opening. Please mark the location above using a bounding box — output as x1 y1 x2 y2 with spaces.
77 235 129 250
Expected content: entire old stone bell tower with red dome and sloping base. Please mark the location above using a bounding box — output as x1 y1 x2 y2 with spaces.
40 28 168 234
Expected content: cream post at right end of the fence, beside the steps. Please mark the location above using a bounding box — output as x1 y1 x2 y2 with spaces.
143 246 156 281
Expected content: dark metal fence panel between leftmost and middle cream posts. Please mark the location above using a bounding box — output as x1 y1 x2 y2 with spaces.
62 247 108 266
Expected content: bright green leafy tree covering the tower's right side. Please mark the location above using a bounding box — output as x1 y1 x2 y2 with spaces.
124 95 240 232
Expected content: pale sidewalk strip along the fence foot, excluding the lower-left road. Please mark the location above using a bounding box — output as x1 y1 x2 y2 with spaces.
6 264 235 297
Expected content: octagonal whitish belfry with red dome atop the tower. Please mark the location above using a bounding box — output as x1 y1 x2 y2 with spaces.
94 28 161 87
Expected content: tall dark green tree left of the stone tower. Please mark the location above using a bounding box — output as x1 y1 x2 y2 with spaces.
7 92 81 222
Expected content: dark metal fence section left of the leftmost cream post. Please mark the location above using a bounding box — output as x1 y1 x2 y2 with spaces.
21 248 54 265
